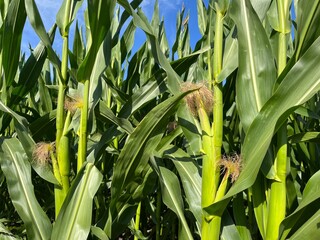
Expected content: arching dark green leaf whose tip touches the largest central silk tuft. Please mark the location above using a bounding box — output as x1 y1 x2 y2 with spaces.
111 92 194 201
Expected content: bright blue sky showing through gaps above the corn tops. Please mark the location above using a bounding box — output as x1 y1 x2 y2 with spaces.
22 0 208 55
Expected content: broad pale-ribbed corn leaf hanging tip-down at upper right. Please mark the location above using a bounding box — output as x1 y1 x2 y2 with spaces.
230 0 276 132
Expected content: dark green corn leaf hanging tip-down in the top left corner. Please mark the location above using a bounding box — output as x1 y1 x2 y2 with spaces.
2 0 26 86
